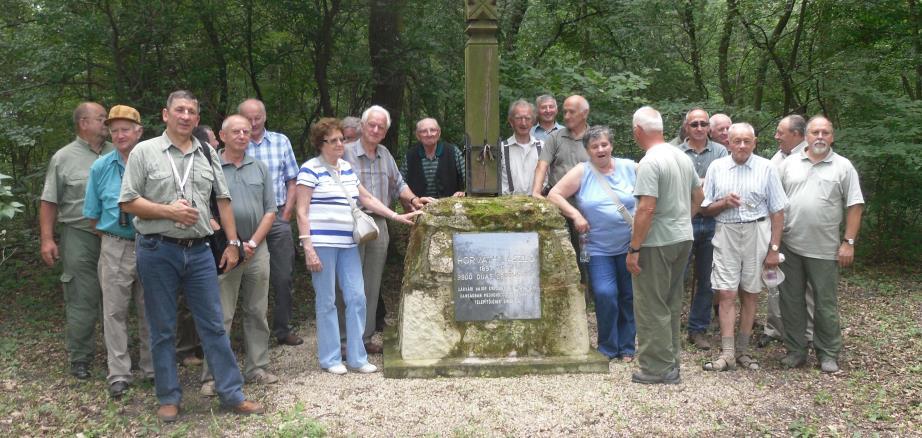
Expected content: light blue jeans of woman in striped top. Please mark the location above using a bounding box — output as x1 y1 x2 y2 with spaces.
311 246 368 369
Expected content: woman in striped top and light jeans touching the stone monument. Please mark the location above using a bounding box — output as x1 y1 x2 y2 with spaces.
296 117 422 374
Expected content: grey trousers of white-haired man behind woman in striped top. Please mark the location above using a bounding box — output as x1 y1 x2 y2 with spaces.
336 215 391 342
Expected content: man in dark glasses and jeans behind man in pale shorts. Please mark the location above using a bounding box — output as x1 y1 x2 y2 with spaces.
678 108 727 350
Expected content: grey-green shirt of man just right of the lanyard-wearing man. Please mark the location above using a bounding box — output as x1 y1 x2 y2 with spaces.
221 155 278 242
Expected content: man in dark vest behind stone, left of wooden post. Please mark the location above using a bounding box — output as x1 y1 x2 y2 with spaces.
402 118 465 198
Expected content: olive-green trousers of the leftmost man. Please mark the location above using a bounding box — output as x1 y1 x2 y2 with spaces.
61 225 102 364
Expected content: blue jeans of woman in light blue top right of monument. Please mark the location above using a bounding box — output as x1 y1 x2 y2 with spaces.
589 254 637 359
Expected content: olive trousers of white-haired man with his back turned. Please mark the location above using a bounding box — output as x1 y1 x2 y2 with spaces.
632 240 692 376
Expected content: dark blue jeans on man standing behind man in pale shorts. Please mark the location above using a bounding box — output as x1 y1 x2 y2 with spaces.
685 216 717 334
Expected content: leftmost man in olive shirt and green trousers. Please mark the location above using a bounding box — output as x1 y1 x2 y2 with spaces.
39 102 112 379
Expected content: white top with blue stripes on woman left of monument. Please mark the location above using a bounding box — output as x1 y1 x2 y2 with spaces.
298 157 359 248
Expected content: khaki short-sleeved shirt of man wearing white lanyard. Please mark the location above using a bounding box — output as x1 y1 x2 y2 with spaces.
118 132 231 239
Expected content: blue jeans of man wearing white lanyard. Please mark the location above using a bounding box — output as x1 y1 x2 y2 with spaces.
135 235 244 406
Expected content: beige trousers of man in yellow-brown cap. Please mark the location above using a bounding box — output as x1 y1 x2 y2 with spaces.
99 234 154 385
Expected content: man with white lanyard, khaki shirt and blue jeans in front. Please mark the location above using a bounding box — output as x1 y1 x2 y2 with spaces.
119 90 263 422
